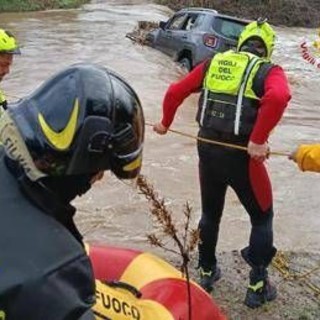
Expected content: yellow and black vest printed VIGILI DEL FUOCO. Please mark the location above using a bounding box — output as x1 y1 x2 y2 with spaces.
197 50 272 136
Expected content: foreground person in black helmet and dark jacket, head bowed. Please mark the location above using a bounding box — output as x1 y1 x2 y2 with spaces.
0 64 144 320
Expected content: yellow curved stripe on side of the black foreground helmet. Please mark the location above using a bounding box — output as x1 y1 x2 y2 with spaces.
38 99 79 150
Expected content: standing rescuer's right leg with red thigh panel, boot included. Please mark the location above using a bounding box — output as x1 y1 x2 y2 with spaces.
232 158 276 308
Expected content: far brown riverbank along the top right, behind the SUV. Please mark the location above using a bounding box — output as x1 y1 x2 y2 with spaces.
155 0 320 28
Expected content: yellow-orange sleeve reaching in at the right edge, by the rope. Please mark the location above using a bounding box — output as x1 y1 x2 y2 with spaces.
295 144 320 172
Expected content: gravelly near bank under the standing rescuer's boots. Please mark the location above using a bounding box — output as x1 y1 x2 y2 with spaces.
171 250 320 320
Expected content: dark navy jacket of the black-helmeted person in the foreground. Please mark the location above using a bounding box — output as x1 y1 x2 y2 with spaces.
0 147 95 320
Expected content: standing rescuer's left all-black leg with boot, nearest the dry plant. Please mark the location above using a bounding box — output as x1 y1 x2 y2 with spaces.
198 148 227 292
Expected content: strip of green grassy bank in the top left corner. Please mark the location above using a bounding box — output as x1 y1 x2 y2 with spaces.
0 0 90 12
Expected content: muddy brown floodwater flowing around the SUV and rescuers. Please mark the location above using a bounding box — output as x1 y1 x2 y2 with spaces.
0 0 320 253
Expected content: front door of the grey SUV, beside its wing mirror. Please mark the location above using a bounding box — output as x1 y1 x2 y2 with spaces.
157 13 188 56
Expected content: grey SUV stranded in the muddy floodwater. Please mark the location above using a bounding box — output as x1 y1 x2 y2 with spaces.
146 8 250 70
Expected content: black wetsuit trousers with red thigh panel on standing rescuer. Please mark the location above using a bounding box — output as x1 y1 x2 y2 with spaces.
198 129 275 269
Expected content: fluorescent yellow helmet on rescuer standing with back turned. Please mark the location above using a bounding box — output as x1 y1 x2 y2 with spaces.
237 19 276 59
